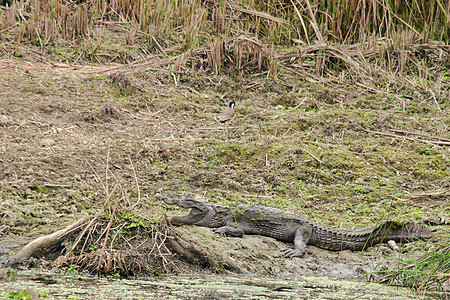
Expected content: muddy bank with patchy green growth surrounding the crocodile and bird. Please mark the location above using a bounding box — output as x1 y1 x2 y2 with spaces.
0 52 450 294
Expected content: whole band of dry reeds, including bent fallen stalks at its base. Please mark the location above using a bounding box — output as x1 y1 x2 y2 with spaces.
0 0 450 84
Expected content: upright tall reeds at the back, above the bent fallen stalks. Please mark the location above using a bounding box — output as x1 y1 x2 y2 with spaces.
0 0 450 44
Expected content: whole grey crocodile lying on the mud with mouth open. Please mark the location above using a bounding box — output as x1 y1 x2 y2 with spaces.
156 194 433 258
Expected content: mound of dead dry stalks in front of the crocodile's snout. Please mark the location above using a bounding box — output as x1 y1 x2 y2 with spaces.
46 152 178 277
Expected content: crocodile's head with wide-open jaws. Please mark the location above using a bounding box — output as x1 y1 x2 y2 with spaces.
156 194 226 228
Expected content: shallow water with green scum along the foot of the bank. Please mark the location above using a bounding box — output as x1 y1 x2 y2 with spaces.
0 269 437 299
